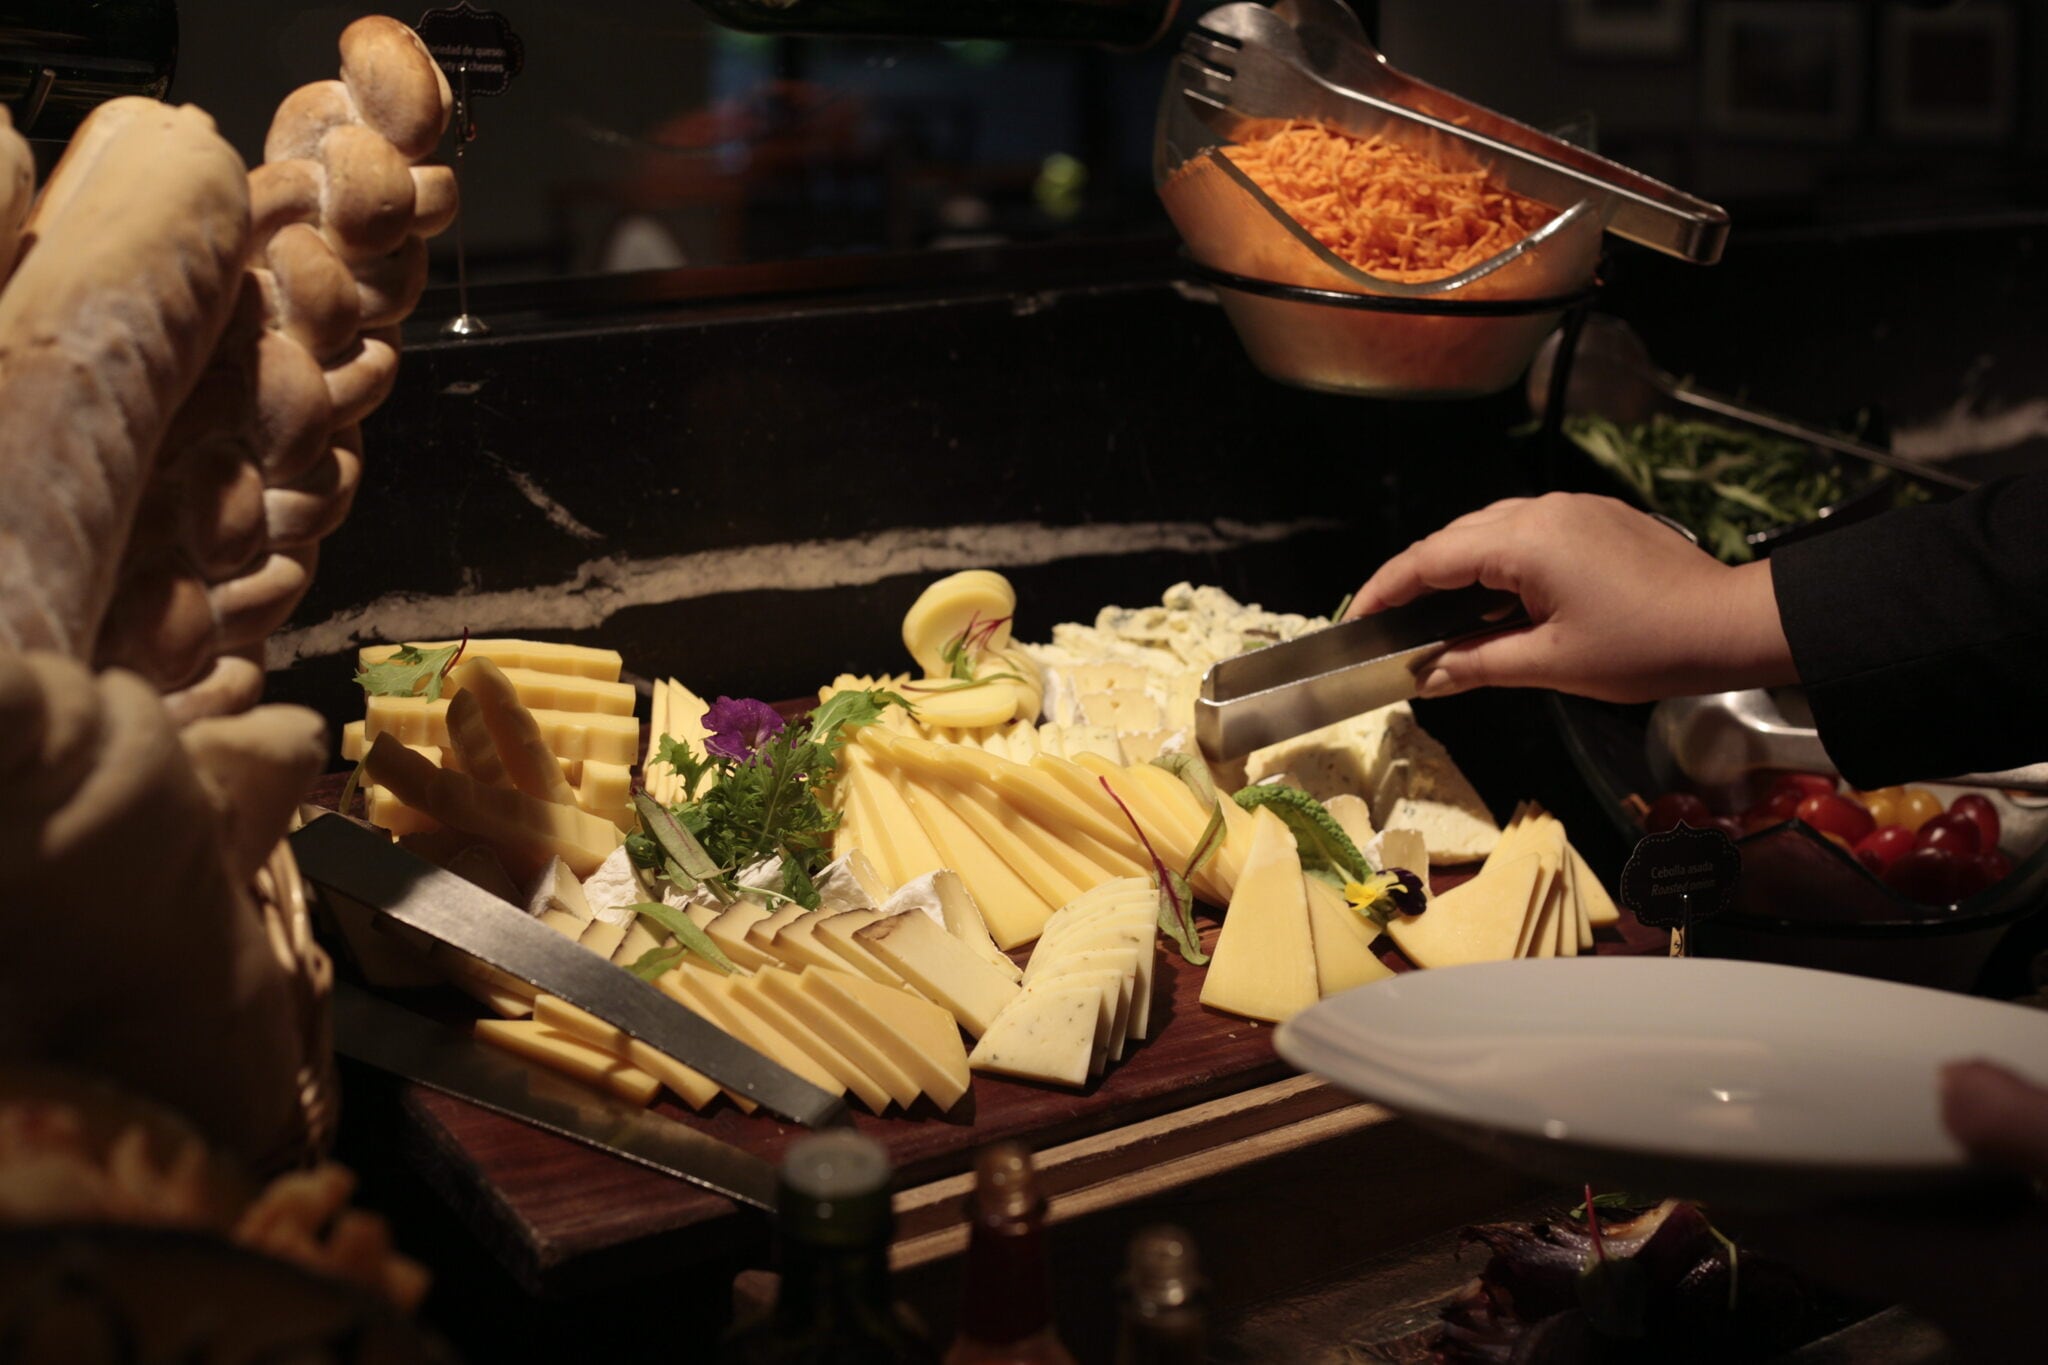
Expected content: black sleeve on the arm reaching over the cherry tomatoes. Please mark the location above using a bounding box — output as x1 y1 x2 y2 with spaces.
1772 473 2048 788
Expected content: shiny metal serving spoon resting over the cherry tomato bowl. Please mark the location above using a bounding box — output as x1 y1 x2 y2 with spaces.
1645 688 2048 792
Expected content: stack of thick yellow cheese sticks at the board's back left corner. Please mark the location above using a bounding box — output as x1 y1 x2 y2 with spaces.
342 639 639 843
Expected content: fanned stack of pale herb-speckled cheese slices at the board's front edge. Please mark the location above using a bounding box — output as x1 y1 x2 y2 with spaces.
967 876 1159 1085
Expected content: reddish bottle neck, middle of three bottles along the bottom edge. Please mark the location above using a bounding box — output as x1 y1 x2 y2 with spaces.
946 1142 1073 1365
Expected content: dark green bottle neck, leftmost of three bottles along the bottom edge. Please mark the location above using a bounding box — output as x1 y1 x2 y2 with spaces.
719 1132 938 1365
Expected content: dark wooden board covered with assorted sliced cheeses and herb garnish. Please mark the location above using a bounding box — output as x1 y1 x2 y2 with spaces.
319 571 1665 1293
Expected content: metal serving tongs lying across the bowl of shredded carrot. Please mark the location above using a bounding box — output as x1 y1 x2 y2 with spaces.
1161 0 1729 264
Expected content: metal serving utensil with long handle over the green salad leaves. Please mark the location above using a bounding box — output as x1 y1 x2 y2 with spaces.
1526 313 1976 489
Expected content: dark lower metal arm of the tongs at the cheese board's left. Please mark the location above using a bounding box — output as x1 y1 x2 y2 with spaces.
334 980 776 1209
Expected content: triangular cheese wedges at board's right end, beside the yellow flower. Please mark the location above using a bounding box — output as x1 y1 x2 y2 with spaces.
1386 802 1620 966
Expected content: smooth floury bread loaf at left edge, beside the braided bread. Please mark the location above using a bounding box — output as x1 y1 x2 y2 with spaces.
0 98 248 657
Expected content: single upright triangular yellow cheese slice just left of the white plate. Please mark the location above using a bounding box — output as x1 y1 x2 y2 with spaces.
1202 806 1319 1023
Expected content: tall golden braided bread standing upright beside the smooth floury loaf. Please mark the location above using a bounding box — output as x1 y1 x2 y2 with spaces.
94 16 457 720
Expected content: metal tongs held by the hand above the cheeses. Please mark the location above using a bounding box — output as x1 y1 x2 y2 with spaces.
1194 585 1530 759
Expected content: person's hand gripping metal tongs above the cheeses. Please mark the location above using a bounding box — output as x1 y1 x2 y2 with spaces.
1346 493 1798 702
